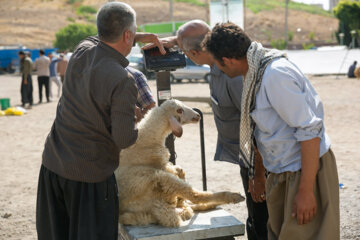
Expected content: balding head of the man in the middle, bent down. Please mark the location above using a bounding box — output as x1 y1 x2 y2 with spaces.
177 20 211 65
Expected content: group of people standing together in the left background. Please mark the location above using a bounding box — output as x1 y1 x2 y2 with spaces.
18 49 68 108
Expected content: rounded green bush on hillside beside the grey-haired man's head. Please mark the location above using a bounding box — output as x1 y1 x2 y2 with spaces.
54 23 97 51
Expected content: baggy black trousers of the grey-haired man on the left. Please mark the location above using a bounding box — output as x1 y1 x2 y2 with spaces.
36 166 119 240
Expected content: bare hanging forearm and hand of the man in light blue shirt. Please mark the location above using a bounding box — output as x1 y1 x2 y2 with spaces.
292 138 320 225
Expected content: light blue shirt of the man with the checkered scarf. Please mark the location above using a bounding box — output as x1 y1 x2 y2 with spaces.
251 58 330 173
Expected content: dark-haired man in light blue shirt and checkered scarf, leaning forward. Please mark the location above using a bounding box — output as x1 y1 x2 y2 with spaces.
203 23 340 240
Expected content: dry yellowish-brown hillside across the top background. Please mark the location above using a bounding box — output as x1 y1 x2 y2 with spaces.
0 0 338 48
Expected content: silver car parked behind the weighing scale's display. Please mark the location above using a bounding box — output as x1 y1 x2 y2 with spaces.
170 58 211 82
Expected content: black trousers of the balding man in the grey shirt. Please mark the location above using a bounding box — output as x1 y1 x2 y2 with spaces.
240 167 269 240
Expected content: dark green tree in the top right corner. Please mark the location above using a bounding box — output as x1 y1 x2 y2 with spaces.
333 0 360 46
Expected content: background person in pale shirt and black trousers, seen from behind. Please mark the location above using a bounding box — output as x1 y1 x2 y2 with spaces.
34 49 50 103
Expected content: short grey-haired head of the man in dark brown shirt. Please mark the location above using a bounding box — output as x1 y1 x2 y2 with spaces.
96 2 136 56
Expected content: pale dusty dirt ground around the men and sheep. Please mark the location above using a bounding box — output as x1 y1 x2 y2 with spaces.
0 75 360 240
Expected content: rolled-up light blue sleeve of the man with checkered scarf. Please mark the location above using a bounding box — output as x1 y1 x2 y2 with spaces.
265 69 323 141
